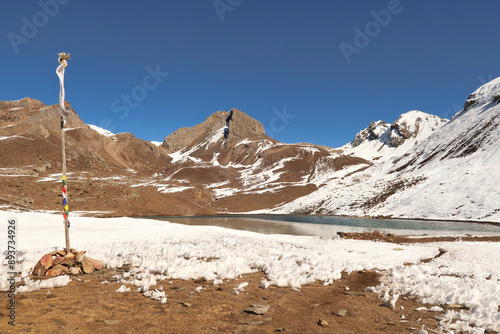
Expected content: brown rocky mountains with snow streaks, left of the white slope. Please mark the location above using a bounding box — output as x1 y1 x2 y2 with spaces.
0 98 369 215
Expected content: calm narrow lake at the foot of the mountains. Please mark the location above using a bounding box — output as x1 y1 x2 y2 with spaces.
148 215 500 236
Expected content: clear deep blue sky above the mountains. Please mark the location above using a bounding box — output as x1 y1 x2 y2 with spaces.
0 0 500 147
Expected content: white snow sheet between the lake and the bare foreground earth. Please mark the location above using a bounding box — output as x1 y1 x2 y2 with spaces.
0 211 500 333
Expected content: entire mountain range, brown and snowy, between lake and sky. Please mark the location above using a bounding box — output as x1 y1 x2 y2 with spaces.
0 78 500 222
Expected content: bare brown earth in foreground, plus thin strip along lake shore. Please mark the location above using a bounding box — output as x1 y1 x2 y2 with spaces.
0 232 500 334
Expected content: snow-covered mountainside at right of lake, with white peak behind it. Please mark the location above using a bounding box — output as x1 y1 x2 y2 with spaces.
276 78 500 222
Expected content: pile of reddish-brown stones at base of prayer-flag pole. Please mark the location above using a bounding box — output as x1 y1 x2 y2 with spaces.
33 248 102 277
